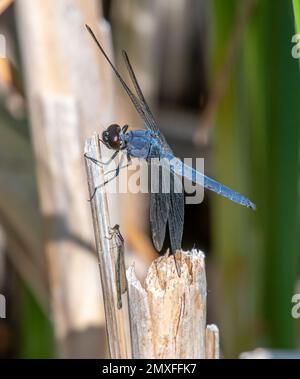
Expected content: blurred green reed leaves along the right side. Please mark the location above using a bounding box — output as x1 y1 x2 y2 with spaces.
212 0 300 356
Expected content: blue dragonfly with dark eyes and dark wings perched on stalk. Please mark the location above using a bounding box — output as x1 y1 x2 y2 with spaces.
86 25 256 252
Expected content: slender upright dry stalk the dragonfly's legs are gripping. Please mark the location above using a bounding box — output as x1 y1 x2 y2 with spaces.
84 136 131 359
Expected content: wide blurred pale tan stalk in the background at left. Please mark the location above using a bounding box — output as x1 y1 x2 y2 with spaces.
16 0 117 358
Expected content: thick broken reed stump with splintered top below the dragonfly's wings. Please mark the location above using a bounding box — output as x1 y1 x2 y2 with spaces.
127 250 219 359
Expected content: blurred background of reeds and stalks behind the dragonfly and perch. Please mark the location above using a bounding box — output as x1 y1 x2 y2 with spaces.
0 0 300 358
